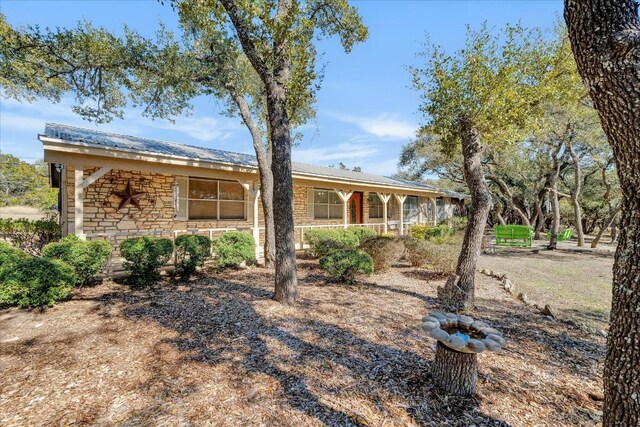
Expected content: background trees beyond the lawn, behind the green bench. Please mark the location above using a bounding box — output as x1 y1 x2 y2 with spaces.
400 27 620 254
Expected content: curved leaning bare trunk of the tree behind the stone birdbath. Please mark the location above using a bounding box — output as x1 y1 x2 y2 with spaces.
438 116 492 311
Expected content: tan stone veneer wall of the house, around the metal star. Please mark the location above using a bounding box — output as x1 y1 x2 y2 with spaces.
63 165 399 252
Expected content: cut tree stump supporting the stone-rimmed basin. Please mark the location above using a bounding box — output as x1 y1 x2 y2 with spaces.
431 341 478 396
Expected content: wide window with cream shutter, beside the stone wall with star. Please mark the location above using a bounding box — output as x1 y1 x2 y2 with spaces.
174 178 246 220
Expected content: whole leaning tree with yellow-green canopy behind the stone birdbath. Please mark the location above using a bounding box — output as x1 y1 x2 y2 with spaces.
412 25 551 310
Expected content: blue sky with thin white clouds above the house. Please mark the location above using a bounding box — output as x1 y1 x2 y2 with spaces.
0 0 562 175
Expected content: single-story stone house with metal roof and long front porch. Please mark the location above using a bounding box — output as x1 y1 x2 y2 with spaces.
38 123 464 260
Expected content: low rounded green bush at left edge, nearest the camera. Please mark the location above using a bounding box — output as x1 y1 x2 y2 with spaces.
0 255 76 308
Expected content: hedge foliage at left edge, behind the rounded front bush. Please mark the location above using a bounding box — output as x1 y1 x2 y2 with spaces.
0 218 62 255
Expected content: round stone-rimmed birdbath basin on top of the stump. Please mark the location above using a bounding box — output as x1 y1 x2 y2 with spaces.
422 312 506 354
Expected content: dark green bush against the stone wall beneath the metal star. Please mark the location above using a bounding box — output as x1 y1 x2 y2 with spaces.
120 237 173 285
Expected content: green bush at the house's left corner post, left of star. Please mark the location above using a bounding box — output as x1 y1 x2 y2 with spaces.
42 235 111 285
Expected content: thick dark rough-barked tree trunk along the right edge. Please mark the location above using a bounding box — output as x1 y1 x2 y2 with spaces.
564 0 640 427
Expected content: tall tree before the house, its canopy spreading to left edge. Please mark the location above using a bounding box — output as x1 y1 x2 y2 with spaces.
0 0 367 303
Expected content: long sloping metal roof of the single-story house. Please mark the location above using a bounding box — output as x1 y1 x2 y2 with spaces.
42 123 465 198
